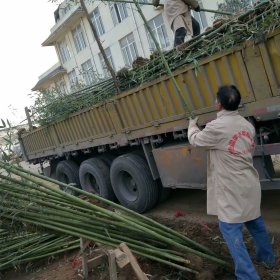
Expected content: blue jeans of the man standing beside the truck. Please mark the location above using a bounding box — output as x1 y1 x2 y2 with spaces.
219 217 276 280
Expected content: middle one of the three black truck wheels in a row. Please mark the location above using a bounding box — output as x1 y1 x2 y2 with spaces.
79 158 116 201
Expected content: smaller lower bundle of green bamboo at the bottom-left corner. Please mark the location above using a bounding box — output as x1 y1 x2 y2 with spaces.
0 221 80 271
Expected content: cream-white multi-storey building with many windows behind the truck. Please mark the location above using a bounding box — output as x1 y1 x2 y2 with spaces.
33 0 223 93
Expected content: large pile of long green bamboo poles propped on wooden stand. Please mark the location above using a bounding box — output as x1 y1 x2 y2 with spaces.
0 161 230 274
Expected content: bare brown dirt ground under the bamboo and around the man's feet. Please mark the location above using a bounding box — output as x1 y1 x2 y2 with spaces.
0 190 280 280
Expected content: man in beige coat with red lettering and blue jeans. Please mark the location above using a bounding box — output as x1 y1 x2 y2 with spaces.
188 85 276 280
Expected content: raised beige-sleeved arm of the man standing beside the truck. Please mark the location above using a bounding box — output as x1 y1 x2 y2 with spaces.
188 119 221 149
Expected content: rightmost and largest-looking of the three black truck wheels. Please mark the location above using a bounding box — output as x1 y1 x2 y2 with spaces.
110 154 159 213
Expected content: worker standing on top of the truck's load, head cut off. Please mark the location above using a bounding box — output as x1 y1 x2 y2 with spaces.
153 0 200 47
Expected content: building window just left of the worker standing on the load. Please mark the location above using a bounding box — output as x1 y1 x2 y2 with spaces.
147 15 170 51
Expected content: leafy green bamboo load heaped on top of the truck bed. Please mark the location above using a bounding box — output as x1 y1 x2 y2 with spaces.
32 0 280 124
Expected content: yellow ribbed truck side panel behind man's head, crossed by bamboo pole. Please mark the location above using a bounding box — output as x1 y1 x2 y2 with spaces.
115 47 255 134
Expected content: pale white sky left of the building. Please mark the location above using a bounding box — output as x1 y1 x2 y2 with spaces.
0 0 58 125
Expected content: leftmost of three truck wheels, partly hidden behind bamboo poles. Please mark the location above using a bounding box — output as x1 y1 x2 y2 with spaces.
55 160 80 195
